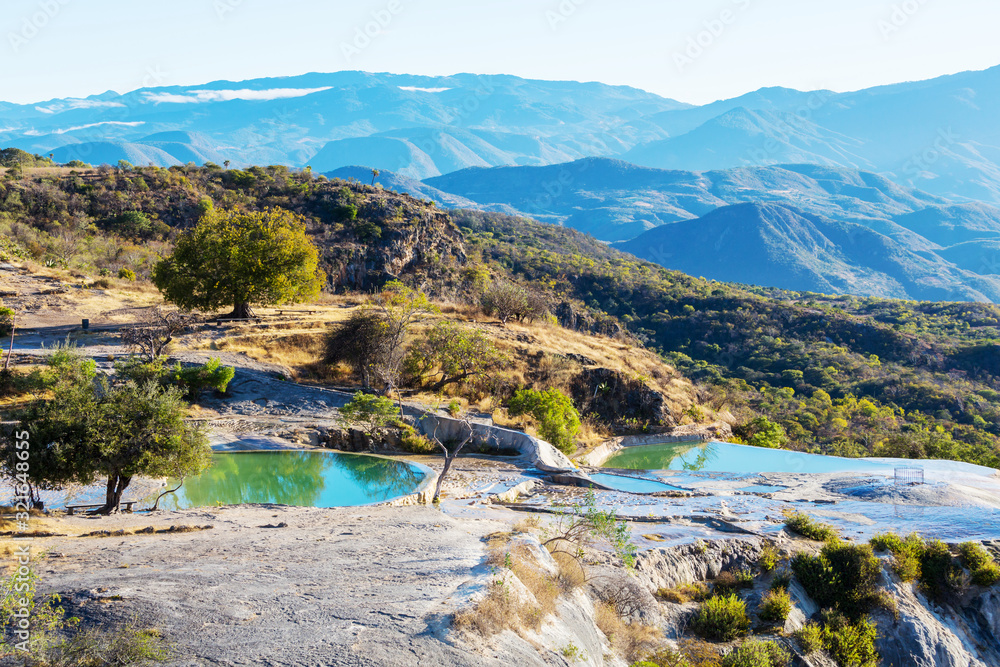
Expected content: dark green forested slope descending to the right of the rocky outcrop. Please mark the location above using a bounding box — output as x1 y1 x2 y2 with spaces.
454 212 1000 467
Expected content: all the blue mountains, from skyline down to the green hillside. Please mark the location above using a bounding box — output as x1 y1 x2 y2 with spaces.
0 67 1000 301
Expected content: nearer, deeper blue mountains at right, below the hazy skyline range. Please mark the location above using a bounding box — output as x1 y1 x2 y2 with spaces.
328 158 1000 302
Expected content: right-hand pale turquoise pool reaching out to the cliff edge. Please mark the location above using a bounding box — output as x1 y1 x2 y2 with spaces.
604 442 996 475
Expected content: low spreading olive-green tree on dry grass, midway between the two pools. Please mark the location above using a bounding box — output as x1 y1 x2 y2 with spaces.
407 322 508 391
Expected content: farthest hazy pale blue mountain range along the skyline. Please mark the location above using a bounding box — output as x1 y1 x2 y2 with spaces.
0 67 1000 204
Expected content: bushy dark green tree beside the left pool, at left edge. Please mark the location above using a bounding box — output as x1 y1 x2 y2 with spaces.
0 351 211 514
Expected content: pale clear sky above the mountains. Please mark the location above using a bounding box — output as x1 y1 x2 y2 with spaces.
0 0 1000 104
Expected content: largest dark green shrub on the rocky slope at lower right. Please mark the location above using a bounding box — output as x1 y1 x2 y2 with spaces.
792 542 882 619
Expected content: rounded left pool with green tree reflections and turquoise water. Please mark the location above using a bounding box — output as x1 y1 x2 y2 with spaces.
154 451 426 509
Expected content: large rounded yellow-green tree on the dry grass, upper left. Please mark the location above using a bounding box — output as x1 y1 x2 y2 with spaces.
153 207 325 319
